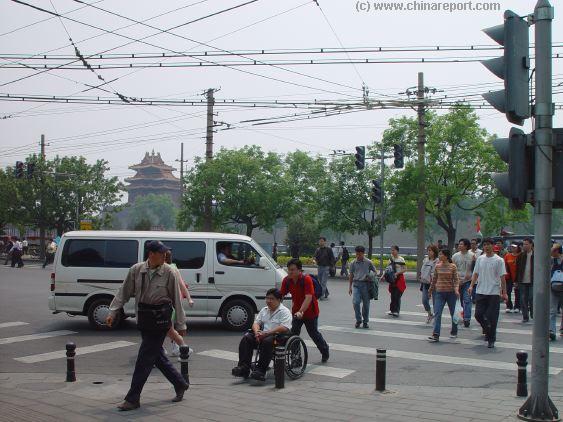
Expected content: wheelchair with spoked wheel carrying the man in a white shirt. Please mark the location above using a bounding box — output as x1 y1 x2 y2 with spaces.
249 330 308 380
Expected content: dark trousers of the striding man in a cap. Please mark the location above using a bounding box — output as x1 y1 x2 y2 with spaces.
125 331 186 403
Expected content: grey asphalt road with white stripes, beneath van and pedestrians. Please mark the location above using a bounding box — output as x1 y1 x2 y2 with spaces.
0 265 563 396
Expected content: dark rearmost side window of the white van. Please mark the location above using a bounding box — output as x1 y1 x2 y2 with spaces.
62 239 139 268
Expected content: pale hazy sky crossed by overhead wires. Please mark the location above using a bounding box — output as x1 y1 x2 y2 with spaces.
0 0 563 198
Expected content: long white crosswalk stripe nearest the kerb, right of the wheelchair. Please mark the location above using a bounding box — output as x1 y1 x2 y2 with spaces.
305 340 563 375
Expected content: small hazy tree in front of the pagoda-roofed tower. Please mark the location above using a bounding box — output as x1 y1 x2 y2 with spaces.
129 193 178 230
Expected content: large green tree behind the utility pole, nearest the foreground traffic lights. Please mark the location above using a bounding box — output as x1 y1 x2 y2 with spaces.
383 104 505 249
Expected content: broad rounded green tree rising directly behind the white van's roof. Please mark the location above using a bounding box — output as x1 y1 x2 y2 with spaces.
178 145 289 236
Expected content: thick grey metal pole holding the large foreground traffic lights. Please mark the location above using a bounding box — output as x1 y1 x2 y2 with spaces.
518 0 559 421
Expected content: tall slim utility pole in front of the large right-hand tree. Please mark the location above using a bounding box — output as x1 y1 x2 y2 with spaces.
416 72 426 279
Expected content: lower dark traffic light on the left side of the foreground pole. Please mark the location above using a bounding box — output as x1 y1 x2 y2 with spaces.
492 127 535 209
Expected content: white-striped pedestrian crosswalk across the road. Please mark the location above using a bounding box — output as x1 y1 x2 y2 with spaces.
0 311 563 379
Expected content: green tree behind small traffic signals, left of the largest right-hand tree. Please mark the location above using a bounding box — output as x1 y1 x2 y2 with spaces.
319 156 381 258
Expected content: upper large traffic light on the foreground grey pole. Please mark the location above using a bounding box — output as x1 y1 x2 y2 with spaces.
482 10 530 125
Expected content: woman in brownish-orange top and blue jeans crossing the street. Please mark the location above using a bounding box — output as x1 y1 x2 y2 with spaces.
428 249 459 343
